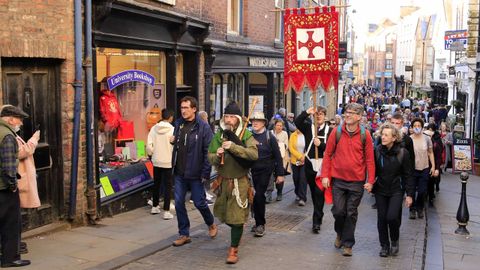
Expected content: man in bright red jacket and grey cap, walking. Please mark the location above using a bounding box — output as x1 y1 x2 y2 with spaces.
320 103 375 256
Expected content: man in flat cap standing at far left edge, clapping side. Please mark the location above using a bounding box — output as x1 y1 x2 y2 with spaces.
0 105 30 268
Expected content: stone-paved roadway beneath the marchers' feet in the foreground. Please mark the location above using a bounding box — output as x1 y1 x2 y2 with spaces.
121 179 425 269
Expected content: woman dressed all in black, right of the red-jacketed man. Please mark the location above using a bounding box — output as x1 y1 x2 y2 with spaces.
372 123 415 257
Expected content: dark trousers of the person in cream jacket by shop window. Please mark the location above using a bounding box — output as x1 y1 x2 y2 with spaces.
152 167 172 211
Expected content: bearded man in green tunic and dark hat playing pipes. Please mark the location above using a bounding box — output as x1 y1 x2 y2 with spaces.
208 102 258 264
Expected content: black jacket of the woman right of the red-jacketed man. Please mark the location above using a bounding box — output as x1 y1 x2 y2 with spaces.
374 143 415 197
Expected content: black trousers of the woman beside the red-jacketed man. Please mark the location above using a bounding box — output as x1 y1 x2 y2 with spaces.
375 193 403 247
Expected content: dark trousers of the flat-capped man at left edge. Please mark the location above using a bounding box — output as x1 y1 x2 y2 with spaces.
0 189 21 263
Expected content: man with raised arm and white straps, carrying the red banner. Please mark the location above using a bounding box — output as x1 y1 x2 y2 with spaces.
295 106 331 234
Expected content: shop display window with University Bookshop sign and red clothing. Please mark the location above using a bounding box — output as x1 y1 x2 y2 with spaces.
96 48 166 202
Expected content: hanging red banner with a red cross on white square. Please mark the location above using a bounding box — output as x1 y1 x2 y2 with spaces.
284 7 339 92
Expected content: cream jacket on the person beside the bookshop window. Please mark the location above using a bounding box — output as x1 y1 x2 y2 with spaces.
147 121 174 168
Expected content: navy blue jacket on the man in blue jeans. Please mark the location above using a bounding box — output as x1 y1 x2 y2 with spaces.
172 115 213 180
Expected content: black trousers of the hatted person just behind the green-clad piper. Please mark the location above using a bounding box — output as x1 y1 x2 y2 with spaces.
251 167 273 226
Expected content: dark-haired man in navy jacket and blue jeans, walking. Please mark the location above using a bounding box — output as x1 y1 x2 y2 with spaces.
171 96 217 246
